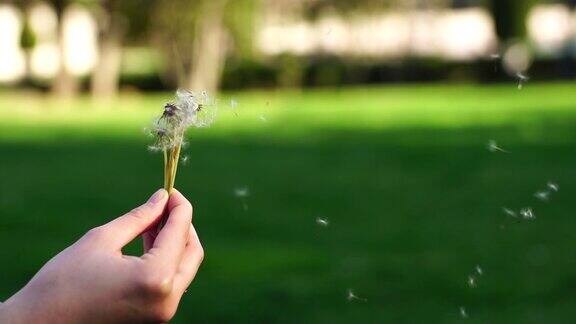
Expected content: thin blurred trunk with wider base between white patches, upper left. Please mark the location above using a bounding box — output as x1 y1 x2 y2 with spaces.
51 0 80 97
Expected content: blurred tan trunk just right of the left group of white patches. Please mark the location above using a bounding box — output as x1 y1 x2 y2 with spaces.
91 0 126 97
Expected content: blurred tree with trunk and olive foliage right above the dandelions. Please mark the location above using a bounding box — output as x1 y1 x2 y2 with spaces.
153 0 258 92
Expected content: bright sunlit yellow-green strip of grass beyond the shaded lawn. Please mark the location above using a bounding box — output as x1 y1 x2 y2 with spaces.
0 83 576 140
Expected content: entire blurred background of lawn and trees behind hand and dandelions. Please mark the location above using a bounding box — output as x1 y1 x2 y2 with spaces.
0 0 576 323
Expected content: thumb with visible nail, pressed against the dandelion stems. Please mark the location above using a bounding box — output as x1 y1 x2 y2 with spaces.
100 189 168 249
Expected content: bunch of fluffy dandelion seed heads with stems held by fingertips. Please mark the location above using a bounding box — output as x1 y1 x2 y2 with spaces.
149 90 216 200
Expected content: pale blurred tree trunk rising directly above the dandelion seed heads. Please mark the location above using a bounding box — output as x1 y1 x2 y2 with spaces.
184 0 227 93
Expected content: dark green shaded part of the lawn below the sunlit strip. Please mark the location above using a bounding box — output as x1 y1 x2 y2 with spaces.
0 122 576 323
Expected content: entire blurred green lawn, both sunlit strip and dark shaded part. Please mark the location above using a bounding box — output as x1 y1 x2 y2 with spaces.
0 83 576 323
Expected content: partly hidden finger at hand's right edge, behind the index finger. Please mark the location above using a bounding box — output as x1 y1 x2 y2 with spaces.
174 224 204 293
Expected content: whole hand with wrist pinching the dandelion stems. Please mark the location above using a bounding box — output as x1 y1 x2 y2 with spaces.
0 189 204 324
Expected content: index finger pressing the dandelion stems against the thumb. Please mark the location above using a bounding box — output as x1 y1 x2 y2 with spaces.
145 190 192 272
